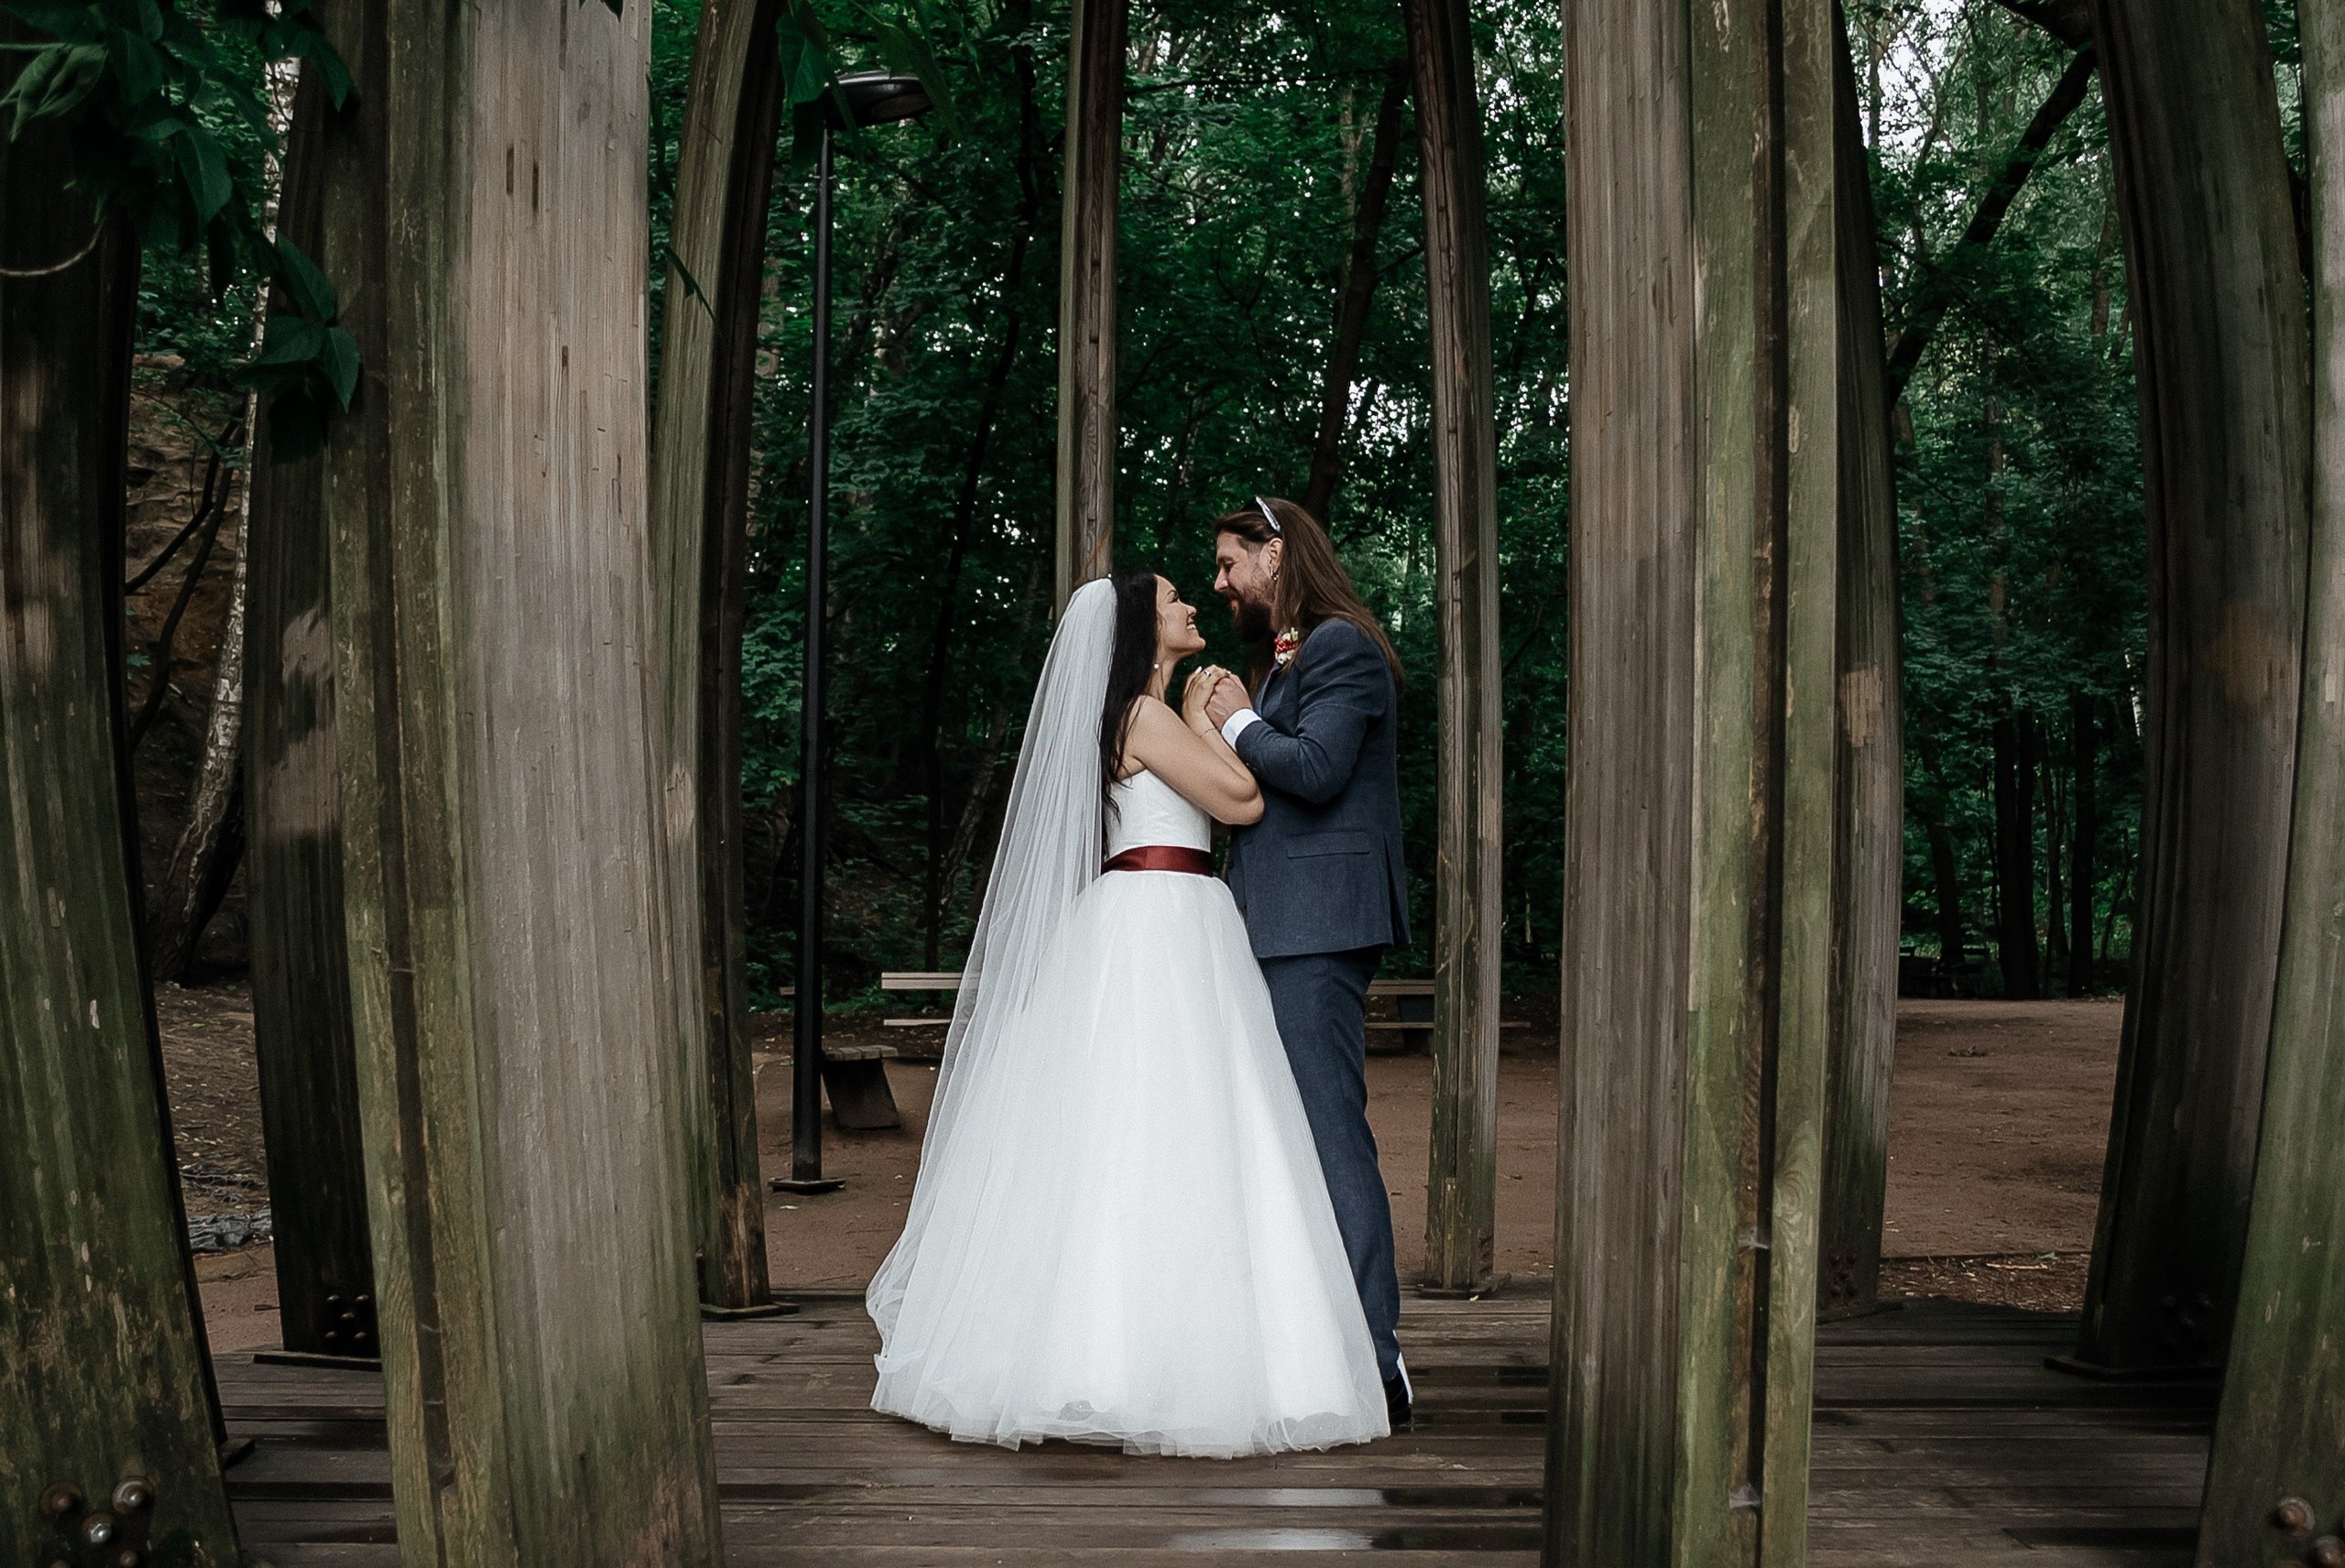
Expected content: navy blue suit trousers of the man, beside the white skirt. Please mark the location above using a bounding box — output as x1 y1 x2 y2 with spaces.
1261 947 1400 1380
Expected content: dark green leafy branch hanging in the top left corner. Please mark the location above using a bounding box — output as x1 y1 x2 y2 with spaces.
0 0 359 460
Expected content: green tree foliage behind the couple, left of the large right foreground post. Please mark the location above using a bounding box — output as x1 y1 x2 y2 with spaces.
654 0 1566 989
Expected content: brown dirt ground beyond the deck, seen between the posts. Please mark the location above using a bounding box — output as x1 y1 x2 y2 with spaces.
178 985 2120 1350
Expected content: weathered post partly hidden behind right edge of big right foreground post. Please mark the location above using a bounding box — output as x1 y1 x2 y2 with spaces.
1817 8 1904 1317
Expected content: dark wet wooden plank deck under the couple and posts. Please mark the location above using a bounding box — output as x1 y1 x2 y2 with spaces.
218 1296 2214 1568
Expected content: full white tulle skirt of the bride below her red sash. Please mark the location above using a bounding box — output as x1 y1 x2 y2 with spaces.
870 872 1389 1458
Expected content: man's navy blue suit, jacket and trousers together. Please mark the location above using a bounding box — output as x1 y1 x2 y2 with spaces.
1228 621 1410 1378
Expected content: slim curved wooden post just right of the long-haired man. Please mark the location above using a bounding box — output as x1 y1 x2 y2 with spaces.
1400 0 1503 1294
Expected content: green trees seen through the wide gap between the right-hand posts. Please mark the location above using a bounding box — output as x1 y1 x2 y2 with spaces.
1850 0 2145 991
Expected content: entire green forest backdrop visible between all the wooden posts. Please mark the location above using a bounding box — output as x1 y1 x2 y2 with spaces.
129 0 2213 1006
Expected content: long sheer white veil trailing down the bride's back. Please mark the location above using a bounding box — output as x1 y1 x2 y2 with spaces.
866 579 1117 1338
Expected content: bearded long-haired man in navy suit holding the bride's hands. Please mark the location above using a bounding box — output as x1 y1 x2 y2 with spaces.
1205 497 1410 1427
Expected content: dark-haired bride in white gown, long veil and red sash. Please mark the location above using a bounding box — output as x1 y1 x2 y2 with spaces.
867 572 1391 1458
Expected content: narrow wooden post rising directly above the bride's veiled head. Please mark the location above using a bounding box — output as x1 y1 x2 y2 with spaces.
1058 0 1130 604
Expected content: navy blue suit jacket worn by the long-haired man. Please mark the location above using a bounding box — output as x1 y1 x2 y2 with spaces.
1228 621 1410 959
